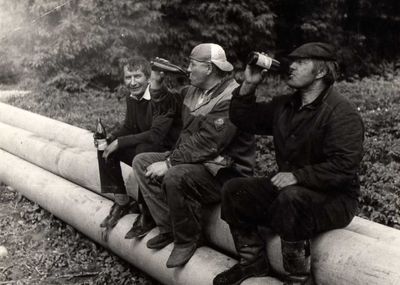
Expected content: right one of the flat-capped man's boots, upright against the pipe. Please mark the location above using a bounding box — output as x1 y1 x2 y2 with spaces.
281 239 314 285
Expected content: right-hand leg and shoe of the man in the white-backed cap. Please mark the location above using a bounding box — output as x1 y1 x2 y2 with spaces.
163 164 227 267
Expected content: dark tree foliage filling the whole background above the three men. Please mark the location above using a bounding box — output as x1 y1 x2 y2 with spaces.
0 0 400 87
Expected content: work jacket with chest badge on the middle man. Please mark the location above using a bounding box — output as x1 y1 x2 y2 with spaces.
169 76 255 176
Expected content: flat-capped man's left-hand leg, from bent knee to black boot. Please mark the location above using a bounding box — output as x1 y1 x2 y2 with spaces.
213 178 278 285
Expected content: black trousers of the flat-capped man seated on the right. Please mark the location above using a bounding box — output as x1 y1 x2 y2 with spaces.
221 178 358 241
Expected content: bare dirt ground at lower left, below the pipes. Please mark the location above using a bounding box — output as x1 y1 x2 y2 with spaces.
0 185 160 285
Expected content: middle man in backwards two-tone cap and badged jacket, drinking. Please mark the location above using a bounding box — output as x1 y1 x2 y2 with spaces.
133 43 255 268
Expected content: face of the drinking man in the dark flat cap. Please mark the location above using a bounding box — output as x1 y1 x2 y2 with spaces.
287 58 316 89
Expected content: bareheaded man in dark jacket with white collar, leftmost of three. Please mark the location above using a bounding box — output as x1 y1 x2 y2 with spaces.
99 57 180 235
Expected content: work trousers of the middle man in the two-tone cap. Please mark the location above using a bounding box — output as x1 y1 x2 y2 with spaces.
132 153 238 247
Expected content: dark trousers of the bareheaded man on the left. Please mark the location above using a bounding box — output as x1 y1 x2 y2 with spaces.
97 144 164 206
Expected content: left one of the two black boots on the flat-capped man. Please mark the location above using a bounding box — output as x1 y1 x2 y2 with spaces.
213 227 269 285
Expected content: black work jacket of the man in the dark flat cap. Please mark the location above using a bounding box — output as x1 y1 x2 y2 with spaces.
230 83 364 197
